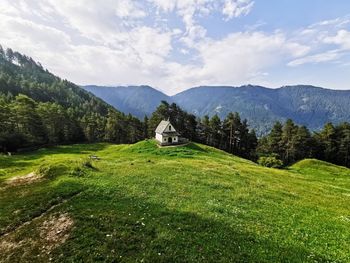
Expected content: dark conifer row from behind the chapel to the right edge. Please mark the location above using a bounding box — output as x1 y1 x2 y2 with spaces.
144 101 350 167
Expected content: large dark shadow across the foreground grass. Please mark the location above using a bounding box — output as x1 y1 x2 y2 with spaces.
48 189 329 262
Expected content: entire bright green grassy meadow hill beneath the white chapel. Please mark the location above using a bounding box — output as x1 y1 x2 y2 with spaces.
0 141 350 262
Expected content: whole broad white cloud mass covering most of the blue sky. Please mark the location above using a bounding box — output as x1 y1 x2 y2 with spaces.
0 0 349 94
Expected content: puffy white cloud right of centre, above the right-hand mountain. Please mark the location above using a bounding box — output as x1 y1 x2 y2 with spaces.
185 32 307 85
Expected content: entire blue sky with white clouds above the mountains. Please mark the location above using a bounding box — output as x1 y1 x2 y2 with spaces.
0 0 350 95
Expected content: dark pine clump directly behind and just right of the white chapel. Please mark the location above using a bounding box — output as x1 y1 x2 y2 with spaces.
144 101 258 160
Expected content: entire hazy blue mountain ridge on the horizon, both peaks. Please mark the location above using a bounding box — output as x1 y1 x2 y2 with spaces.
84 85 350 134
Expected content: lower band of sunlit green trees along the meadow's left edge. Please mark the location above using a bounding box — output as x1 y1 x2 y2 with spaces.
0 94 145 152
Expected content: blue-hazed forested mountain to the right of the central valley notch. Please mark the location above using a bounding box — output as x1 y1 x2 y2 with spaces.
173 85 350 134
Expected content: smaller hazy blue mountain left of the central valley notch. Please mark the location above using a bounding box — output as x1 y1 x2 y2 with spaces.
83 85 172 118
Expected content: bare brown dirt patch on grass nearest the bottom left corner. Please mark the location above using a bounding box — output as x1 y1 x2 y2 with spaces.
40 213 74 253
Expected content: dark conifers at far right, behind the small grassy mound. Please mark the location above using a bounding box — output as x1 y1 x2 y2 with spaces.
257 120 350 167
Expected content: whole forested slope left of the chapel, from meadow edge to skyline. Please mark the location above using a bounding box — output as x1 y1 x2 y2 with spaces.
0 46 144 152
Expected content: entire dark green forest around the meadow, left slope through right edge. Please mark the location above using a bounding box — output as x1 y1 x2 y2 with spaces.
0 46 350 167
